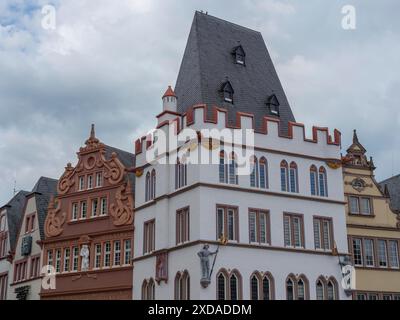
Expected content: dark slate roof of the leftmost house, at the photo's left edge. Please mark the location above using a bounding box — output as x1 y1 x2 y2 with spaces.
2 191 29 251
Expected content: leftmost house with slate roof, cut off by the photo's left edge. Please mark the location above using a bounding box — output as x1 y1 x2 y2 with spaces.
0 191 29 300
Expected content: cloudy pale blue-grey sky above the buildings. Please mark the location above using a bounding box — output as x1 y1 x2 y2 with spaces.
0 0 400 204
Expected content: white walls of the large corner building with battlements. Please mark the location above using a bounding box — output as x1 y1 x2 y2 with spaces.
133 106 350 300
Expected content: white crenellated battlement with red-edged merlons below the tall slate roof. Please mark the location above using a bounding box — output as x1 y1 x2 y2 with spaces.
135 104 341 158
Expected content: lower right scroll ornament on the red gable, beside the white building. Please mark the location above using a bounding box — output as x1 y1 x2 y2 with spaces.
110 181 133 226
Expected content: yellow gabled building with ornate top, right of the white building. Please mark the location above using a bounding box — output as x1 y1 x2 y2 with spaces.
343 131 400 300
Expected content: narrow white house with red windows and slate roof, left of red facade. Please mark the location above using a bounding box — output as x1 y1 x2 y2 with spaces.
8 177 57 300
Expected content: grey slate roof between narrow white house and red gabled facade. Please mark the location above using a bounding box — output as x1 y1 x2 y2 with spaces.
31 177 58 240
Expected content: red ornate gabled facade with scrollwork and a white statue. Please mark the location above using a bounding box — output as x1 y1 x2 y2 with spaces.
41 125 134 299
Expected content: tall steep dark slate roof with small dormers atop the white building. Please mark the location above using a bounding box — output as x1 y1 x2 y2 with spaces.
175 12 295 133
